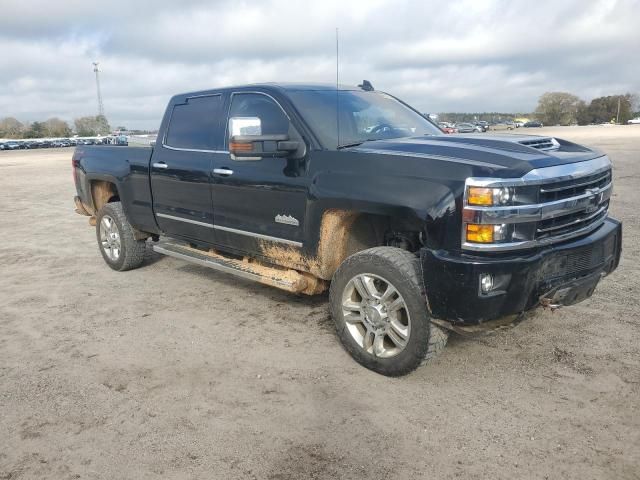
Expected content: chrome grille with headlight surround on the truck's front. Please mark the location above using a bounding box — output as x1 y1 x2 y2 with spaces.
462 156 613 251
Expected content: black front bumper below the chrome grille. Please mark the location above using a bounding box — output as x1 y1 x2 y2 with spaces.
420 218 622 324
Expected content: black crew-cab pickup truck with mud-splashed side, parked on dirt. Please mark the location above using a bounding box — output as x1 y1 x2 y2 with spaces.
73 81 622 375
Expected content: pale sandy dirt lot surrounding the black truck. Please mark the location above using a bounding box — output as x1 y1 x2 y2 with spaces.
0 126 640 479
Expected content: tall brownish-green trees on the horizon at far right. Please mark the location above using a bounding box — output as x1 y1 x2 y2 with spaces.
535 92 640 125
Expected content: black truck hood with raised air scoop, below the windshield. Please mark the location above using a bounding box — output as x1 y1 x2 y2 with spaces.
351 134 603 177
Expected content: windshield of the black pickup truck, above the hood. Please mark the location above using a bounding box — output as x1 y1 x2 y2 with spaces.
287 90 442 148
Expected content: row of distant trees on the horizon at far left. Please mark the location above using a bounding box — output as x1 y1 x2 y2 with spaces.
0 115 111 138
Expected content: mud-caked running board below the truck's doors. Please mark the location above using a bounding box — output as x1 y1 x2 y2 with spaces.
153 242 327 295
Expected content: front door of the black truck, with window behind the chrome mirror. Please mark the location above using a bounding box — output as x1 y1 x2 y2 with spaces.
212 92 309 253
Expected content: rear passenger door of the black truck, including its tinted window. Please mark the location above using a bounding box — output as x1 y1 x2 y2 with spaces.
150 94 225 243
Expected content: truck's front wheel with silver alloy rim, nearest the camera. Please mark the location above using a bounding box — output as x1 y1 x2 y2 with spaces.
329 247 449 377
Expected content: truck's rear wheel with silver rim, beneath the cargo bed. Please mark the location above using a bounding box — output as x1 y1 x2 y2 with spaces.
96 202 146 272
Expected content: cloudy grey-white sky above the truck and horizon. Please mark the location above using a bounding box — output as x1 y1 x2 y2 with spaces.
0 0 640 128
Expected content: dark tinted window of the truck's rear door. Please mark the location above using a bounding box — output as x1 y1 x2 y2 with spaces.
165 95 224 150
